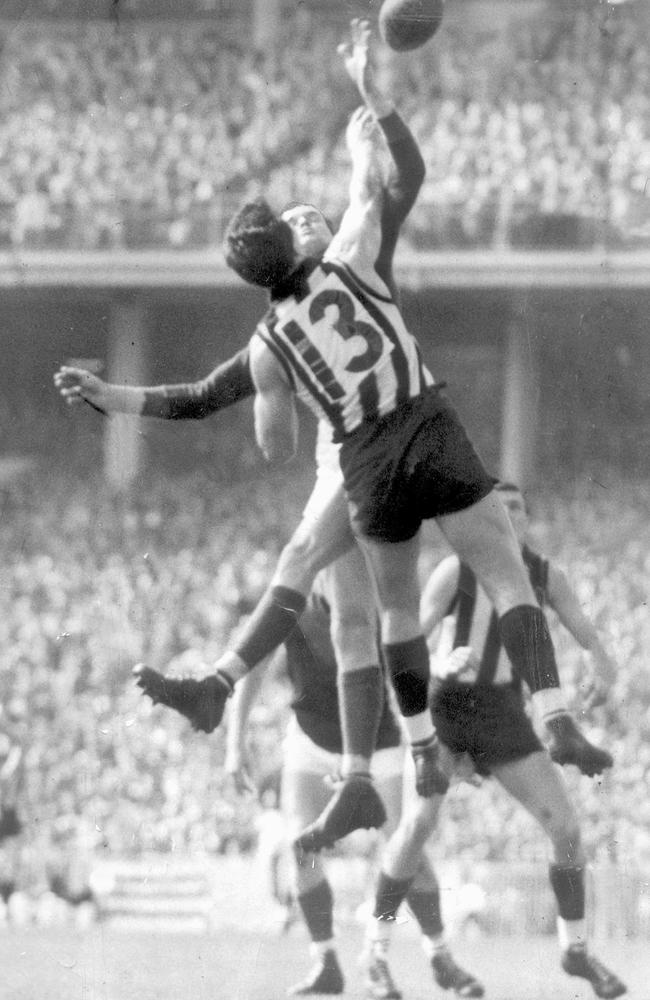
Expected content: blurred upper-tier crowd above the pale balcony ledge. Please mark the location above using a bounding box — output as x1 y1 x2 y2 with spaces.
0 5 650 248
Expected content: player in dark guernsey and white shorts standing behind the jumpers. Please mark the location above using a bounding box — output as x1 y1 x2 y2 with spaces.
225 547 483 997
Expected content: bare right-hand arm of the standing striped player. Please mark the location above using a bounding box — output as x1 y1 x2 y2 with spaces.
547 565 616 708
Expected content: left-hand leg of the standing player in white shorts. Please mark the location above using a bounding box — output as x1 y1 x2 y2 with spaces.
282 719 344 996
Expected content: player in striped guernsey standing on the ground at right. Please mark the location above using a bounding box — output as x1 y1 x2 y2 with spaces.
366 484 626 998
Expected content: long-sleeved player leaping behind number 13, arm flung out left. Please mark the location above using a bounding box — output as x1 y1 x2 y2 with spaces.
55 17 424 836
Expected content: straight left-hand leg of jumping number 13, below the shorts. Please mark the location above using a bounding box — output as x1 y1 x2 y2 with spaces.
359 532 448 795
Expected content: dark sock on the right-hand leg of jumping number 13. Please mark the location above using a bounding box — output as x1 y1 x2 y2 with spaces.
499 604 560 694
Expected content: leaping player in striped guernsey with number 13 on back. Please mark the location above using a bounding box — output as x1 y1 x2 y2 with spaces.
142 22 608 828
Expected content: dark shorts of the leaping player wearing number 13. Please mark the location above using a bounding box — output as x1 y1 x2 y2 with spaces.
340 387 495 542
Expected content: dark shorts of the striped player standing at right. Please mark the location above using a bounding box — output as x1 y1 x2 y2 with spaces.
431 681 544 775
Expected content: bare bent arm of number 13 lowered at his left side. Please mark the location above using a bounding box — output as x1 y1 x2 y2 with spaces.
251 336 298 462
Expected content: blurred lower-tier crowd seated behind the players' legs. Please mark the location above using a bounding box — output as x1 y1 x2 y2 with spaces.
0 450 650 916
